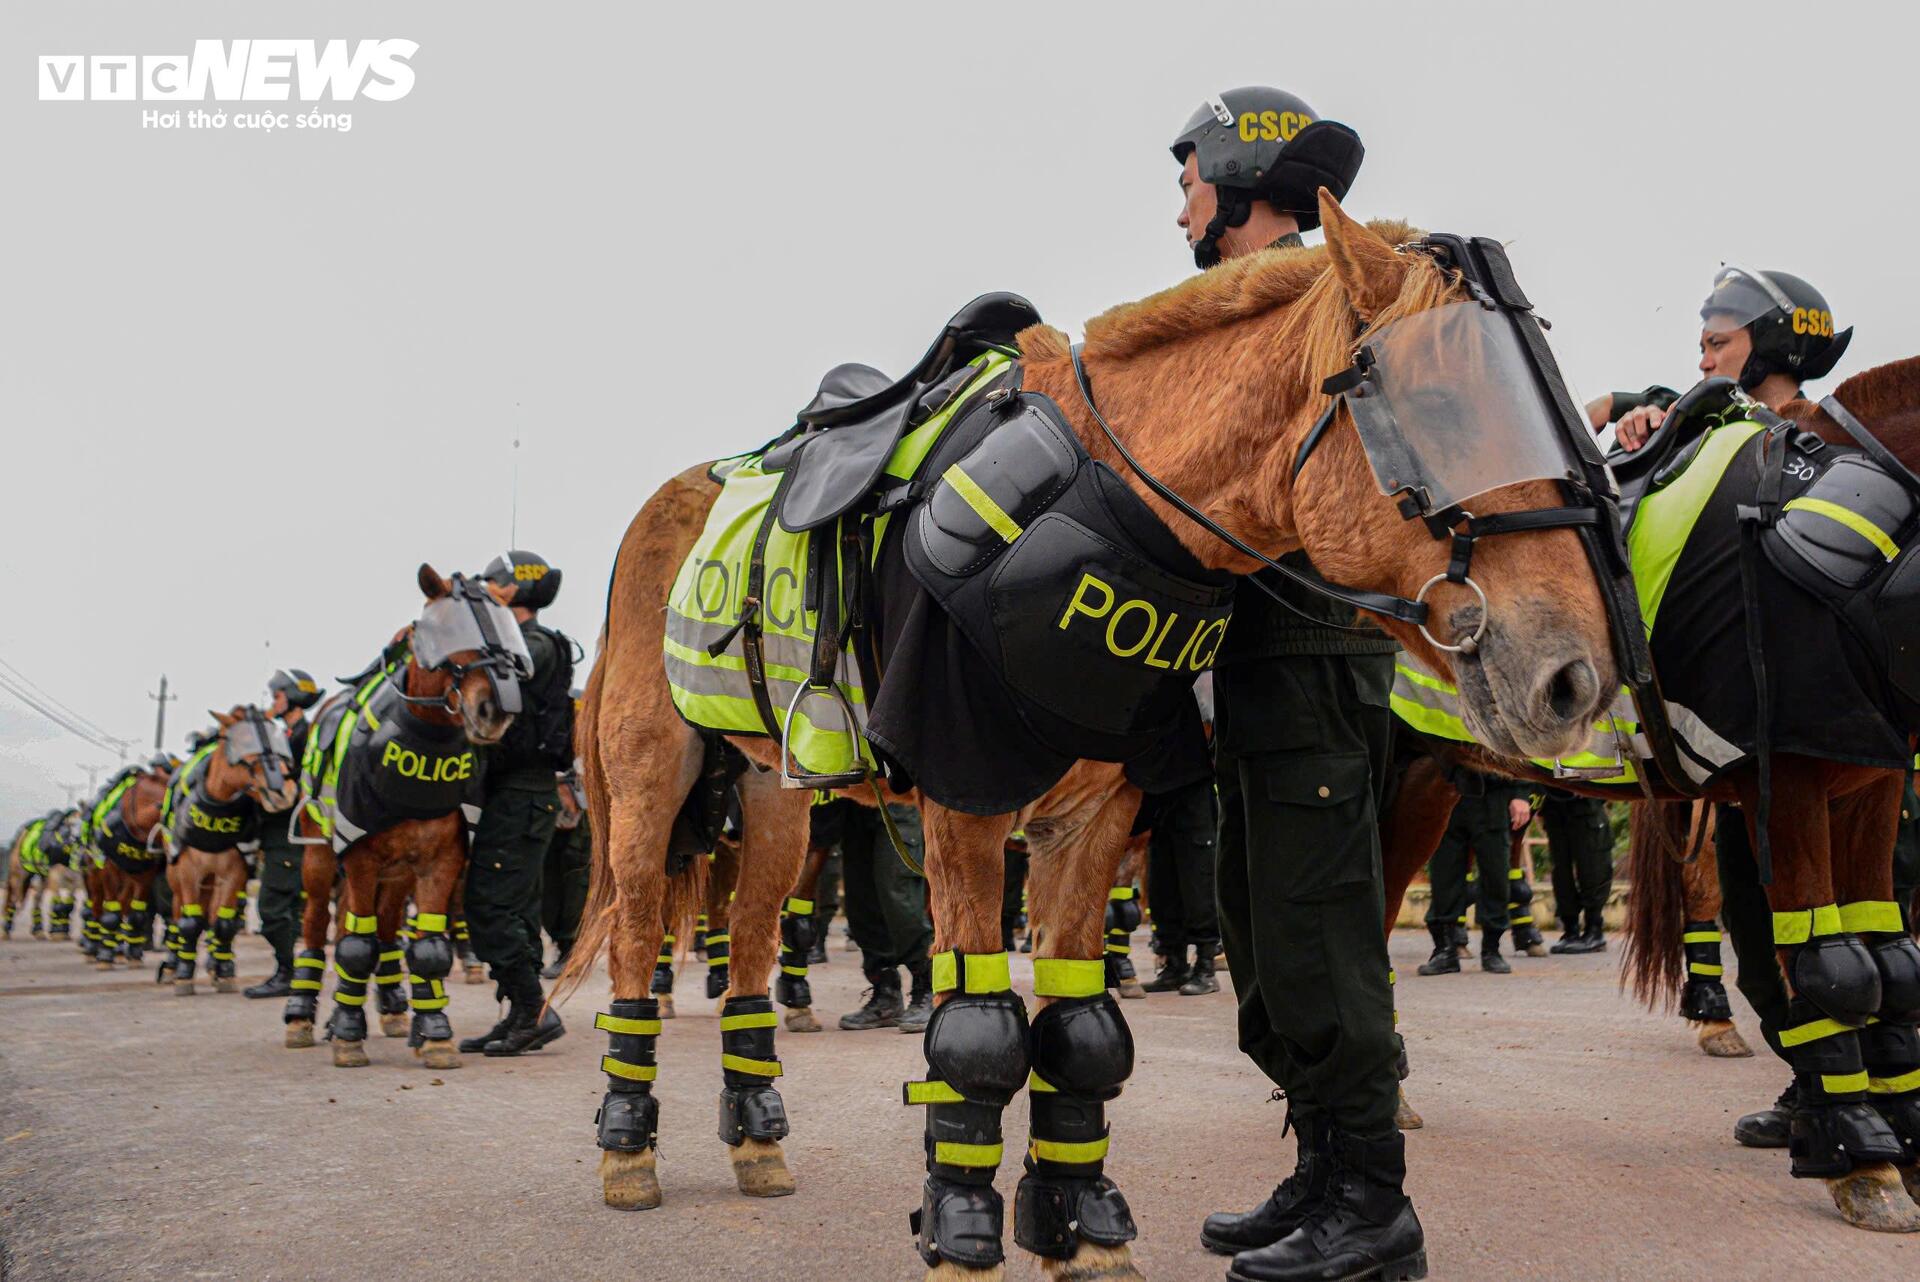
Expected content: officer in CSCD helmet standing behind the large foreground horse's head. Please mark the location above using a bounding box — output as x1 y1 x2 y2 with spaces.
1173 88 1427 1282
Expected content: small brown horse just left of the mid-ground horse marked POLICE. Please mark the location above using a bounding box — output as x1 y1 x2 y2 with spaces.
161 706 298 998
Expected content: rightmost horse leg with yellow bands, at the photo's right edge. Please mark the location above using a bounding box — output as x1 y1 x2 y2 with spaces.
1832 775 1920 1232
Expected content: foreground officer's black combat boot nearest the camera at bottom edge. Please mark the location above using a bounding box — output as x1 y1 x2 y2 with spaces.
1227 1130 1427 1282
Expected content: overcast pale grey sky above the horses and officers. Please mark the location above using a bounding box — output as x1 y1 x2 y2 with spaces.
0 0 1920 829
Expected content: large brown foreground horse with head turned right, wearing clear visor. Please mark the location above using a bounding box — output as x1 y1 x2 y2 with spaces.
574 192 1615 1278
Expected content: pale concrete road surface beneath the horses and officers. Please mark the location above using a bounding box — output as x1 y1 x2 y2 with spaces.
0 931 1920 1282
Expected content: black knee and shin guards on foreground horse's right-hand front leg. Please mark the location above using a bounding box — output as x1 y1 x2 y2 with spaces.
1014 992 1139 1259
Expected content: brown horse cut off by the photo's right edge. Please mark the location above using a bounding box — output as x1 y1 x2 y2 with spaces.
1380 357 1920 1232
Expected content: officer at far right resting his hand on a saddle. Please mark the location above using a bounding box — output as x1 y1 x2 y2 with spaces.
1588 267 1873 1148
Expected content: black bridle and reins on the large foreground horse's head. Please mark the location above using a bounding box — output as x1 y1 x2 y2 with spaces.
1071 236 1630 670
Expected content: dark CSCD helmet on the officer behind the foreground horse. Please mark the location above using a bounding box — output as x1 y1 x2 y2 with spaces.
1173 84 1367 269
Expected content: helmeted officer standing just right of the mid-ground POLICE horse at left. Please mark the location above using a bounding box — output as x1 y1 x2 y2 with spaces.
461 551 574 1056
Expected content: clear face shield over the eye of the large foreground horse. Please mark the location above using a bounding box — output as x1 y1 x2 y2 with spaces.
1344 301 1576 514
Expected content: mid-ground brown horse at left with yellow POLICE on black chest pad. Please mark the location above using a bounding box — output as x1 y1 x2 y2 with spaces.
284 564 530 1069
